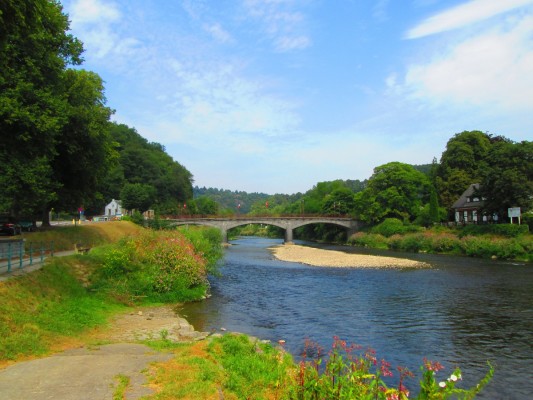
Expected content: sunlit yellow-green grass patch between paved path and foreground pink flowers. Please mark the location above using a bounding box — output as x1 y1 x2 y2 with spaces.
145 334 294 400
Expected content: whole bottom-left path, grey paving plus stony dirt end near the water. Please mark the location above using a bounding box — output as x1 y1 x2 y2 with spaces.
0 306 207 400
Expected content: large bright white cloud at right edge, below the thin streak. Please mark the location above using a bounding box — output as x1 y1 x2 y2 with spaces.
402 16 533 112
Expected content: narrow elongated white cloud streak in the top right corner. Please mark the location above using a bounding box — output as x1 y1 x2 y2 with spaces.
406 0 533 39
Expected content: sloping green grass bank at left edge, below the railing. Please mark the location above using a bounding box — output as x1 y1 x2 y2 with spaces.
0 257 121 360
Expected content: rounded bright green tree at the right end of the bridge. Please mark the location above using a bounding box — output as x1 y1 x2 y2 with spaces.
355 162 430 223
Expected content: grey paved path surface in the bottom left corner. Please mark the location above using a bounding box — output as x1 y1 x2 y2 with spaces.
0 343 172 400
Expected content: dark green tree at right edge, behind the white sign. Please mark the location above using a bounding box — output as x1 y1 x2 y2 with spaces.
480 140 533 222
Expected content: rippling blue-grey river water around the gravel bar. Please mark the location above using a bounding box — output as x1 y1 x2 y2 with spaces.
180 238 533 399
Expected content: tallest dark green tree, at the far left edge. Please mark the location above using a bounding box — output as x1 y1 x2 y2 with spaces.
0 0 83 214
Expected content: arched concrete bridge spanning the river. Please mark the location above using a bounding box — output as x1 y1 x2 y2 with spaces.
169 216 360 243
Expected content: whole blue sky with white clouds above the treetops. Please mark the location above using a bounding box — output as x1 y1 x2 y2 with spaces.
62 0 533 194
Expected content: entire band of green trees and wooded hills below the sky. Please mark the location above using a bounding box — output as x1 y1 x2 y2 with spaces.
0 0 533 231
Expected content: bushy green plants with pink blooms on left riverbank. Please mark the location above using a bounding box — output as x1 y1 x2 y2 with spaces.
89 229 222 302
